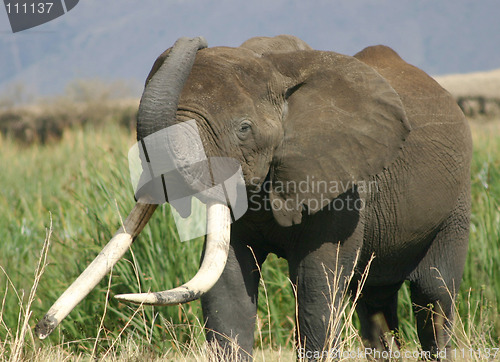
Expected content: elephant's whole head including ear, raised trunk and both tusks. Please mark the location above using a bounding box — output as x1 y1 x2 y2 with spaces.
37 36 409 337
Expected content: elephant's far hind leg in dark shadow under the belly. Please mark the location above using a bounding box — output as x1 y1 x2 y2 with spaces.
356 283 402 350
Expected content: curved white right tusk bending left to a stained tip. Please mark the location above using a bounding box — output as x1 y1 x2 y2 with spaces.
115 203 231 305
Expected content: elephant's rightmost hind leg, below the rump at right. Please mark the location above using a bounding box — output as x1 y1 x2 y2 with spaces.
410 188 470 358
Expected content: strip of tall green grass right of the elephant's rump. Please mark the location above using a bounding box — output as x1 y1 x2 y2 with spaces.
459 121 500 342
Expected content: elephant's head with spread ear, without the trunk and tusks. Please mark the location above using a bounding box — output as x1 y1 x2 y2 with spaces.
157 36 410 226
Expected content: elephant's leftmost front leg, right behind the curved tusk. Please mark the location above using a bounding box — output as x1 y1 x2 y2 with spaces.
201 230 267 361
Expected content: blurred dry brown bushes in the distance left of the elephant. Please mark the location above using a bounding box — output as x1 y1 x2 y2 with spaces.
0 79 138 144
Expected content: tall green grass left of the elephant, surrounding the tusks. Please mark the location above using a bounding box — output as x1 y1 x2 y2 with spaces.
0 125 209 352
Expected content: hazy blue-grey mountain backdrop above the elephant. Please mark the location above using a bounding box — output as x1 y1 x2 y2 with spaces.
0 0 500 96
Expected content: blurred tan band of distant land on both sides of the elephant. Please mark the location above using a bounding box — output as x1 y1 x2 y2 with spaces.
0 69 500 144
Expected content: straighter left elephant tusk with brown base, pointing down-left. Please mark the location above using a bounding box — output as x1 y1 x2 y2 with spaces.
35 200 157 339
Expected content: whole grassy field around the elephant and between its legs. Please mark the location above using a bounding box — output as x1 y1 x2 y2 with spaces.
0 111 500 361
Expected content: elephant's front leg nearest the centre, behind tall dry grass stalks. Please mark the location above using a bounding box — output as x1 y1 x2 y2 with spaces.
289 243 356 356
